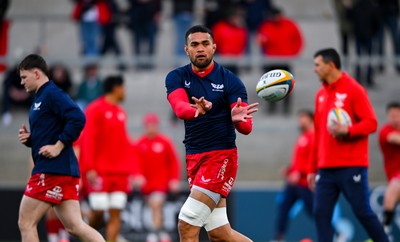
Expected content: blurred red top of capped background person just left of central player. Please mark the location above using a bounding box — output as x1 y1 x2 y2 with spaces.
136 134 180 194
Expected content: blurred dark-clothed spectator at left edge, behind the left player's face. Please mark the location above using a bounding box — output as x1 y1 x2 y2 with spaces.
1 66 33 126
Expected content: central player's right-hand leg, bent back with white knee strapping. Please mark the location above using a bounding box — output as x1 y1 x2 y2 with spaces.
204 198 252 242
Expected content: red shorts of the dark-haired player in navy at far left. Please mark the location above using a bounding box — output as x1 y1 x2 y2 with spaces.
24 173 79 204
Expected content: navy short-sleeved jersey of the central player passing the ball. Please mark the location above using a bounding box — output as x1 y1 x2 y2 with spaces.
165 63 247 154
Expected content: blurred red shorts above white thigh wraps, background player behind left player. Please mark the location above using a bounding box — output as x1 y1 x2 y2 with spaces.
87 175 130 193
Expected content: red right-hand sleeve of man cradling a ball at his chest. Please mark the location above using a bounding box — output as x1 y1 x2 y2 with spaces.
349 89 378 137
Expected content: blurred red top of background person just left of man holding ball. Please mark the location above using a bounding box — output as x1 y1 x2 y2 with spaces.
288 130 314 187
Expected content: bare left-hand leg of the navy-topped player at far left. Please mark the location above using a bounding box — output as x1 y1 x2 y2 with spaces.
18 195 51 242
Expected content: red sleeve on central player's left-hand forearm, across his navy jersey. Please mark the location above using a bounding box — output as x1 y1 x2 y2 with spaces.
168 88 196 120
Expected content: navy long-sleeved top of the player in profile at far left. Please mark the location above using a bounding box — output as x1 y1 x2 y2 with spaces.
28 81 85 177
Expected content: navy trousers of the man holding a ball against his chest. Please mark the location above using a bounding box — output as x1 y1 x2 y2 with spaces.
314 167 389 242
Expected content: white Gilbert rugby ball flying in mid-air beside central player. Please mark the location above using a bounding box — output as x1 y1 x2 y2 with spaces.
256 69 295 102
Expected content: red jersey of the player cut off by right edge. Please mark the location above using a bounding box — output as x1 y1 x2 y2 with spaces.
379 124 400 180
